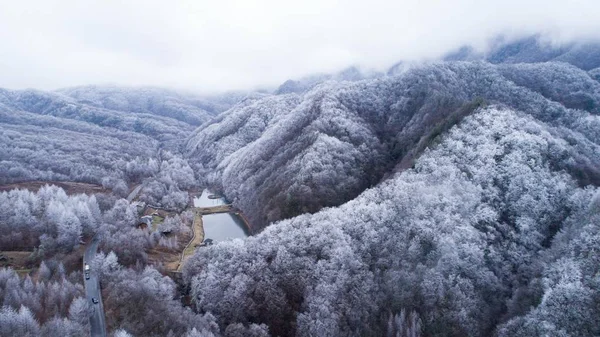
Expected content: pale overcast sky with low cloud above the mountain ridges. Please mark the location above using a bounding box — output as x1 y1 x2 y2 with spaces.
0 0 600 92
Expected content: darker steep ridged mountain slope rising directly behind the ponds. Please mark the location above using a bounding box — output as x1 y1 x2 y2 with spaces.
187 62 600 229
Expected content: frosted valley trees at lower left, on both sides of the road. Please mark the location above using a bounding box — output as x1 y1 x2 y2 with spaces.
0 186 218 337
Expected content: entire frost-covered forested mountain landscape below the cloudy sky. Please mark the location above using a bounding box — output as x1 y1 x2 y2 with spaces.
0 35 600 337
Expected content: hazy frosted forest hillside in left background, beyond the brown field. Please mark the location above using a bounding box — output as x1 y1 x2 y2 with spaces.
0 87 241 187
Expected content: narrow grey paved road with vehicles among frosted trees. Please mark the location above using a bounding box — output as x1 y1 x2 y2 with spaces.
83 238 106 337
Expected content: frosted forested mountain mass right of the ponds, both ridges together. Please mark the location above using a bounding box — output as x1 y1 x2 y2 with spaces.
179 36 600 336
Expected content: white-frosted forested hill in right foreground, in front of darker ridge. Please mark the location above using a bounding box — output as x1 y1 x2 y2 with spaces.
184 106 600 336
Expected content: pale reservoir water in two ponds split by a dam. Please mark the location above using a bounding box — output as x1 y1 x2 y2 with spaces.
194 190 248 242
